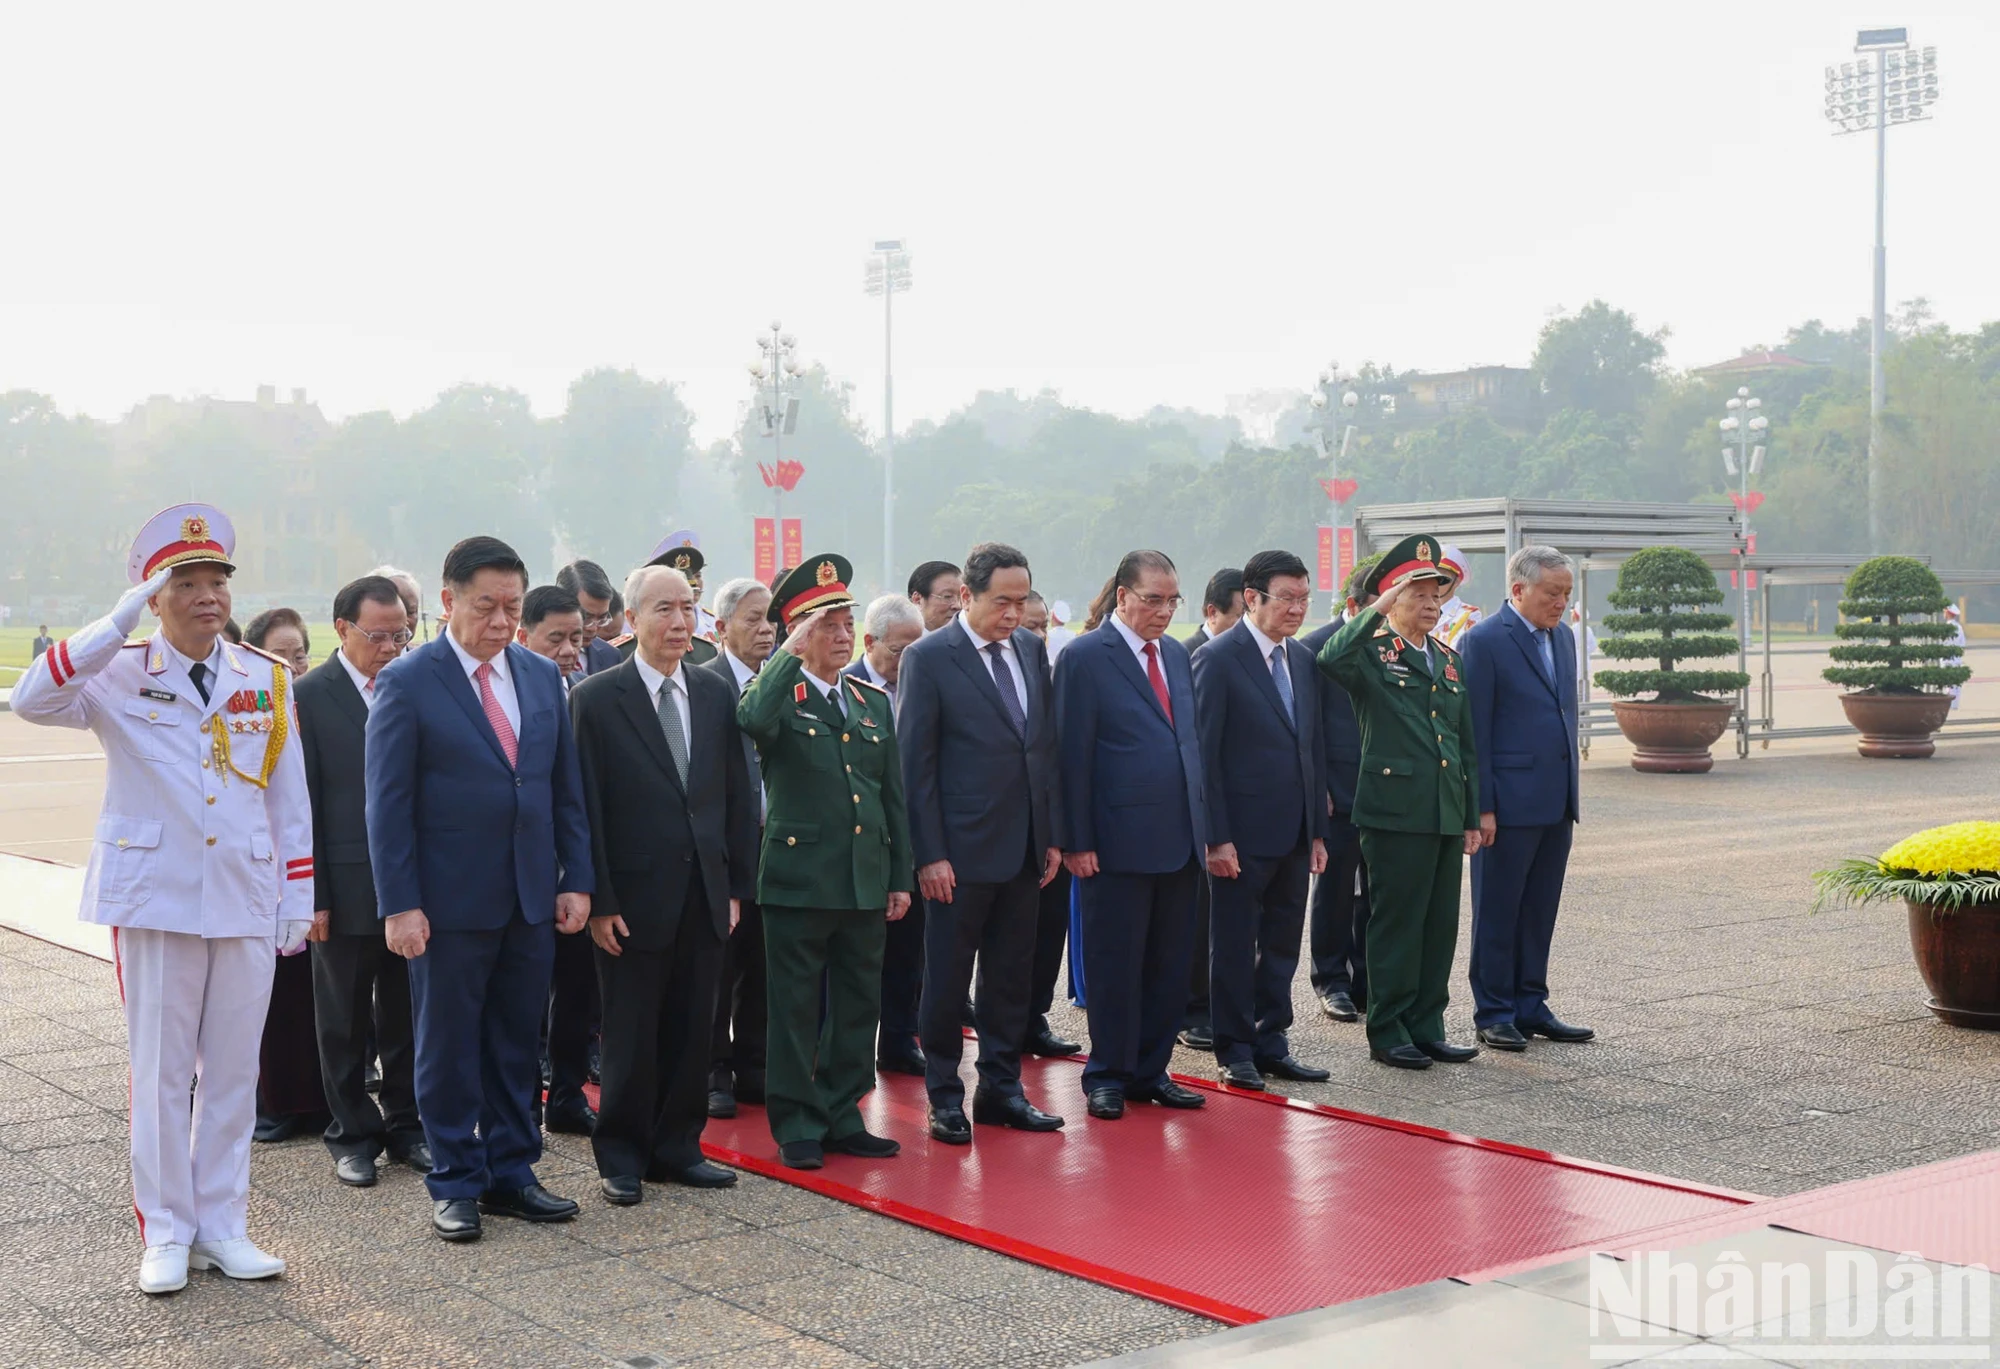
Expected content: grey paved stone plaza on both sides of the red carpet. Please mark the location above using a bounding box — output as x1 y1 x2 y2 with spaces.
0 721 2000 1369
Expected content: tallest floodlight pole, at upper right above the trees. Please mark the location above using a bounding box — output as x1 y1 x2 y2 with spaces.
1826 28 1938 554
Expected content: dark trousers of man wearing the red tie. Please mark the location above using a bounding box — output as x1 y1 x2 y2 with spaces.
1076 861 1200 1093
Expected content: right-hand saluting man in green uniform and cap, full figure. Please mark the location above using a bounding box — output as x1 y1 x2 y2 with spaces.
1320 536 1480 1069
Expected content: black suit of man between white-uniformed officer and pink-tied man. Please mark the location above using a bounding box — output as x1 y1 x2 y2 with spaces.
292 656 424 1157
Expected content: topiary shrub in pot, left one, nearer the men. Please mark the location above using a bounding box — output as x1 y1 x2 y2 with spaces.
1592 546 1750 775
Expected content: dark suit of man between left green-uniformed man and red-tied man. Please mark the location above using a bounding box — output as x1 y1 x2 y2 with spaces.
896 622 1058 1107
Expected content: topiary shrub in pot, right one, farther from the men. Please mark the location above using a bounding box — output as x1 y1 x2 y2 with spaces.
1822 556 1972 759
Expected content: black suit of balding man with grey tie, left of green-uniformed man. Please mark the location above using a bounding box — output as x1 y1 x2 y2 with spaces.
570 660 758 1177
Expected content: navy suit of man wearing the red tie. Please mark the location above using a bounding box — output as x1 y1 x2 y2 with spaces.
1056 618 1208 1093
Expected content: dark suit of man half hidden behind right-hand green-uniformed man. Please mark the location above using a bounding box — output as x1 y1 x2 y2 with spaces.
1298 618 1370 1011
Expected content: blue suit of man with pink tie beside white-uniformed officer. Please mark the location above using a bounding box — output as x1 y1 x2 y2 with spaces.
366 636 594 1199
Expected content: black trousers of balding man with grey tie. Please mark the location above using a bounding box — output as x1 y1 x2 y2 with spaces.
590 897 722 1177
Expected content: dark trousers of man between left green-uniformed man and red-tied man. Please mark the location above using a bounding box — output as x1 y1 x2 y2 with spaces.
924 861 1042 1107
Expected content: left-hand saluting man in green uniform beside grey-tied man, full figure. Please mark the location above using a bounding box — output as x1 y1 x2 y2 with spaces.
736 556 916 1169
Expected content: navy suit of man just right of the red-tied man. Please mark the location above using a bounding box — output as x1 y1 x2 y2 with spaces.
1194 620 1326 1065
